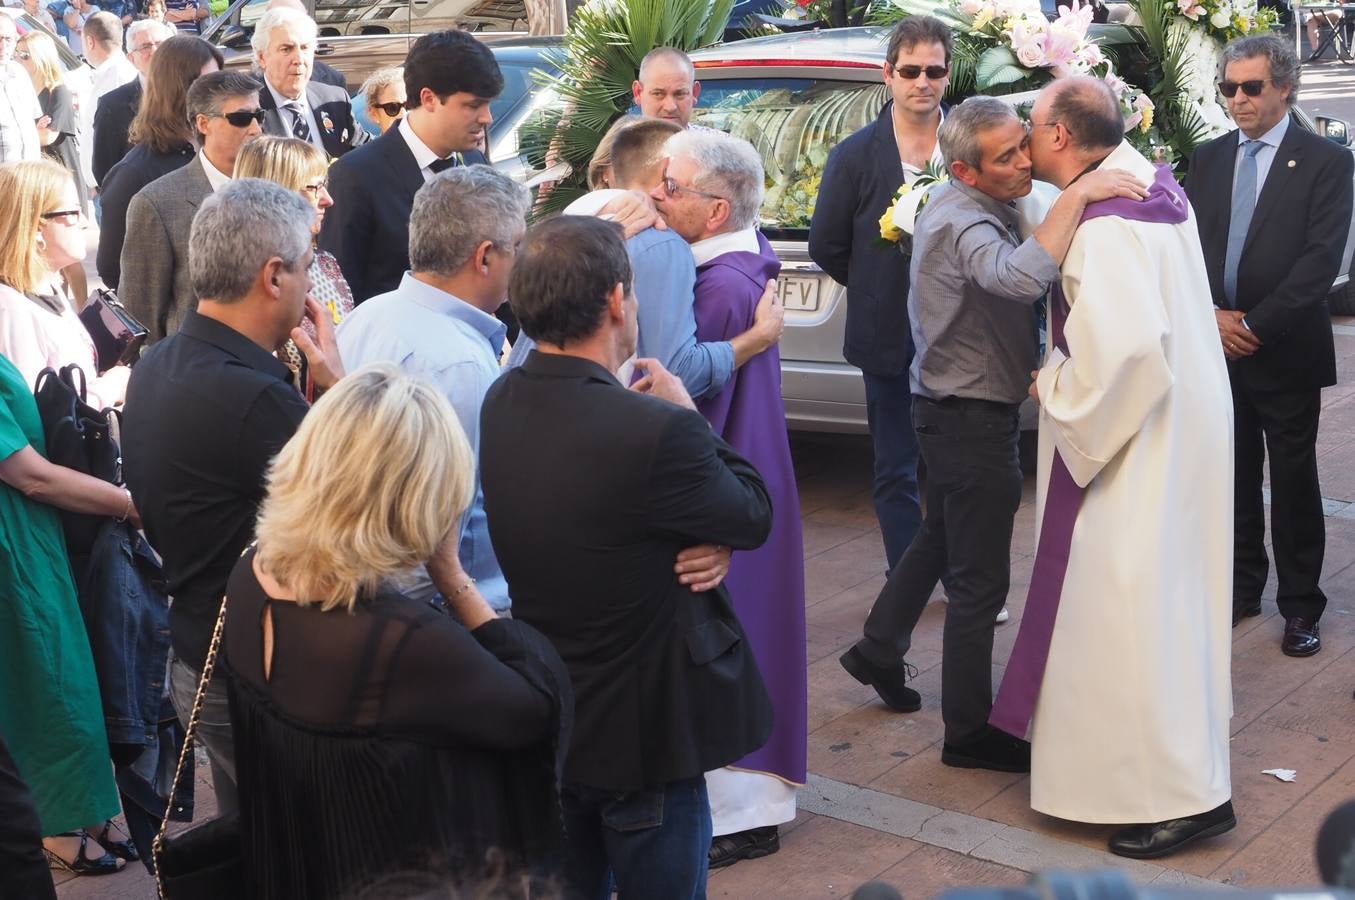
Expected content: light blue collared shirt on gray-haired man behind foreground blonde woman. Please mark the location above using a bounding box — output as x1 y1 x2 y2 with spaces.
339 272 509 611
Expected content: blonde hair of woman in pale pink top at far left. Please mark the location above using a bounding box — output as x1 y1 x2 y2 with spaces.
0 159 72 291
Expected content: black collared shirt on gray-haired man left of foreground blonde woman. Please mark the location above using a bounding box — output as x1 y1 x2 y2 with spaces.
122 310 309 670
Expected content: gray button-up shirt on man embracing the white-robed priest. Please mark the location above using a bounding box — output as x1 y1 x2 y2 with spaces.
908 182 1058 403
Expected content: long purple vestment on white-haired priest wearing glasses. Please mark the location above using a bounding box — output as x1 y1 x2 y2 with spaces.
695 234 809 785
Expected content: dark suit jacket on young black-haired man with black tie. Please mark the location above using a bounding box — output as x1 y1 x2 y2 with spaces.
320 127 486 304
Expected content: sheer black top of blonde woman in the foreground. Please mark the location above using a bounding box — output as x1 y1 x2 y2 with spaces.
224 550 573 900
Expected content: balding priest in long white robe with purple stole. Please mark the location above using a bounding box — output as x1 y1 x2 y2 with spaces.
991 77 1237 859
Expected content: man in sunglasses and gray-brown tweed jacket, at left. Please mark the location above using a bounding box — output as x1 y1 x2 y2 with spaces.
118 72 264 343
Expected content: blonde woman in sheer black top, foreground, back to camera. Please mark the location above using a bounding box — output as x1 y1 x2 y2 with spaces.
218 365 572 900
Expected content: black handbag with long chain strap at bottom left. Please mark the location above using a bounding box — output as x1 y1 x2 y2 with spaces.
150 577 248 900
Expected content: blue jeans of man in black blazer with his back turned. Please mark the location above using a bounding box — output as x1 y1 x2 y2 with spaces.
561 775 711 900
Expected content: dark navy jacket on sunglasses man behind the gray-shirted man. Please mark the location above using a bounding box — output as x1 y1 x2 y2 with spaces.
809 102 913 375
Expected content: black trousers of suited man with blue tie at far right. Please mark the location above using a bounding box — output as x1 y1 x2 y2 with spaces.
1233 381 1327 621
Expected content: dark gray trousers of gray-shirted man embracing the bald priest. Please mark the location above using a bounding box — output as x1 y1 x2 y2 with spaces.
858 397 1022 741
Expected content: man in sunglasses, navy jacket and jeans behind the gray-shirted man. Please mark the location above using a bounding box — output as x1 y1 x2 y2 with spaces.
809 16 951 569
